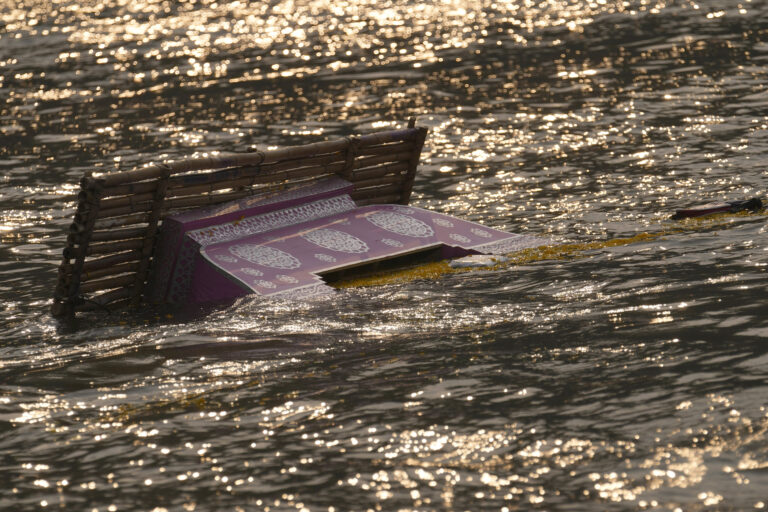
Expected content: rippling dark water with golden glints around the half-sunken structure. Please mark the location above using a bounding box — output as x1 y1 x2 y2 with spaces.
0 0 768 512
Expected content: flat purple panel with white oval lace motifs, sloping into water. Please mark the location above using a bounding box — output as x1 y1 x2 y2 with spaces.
200 205 543 302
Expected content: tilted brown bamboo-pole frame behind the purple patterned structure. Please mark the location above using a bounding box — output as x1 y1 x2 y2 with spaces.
51 121 427 317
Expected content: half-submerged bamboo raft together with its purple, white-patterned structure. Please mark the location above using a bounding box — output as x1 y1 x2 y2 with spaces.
52 123 541 317
